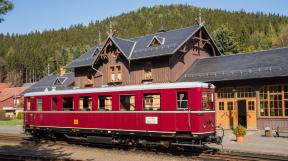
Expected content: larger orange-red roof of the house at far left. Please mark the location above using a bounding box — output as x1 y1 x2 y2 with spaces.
0 87 27 102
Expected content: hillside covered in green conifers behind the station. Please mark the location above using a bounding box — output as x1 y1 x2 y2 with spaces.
0 5 288 83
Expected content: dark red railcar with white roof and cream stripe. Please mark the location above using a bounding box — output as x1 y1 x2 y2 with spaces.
24 82 221 145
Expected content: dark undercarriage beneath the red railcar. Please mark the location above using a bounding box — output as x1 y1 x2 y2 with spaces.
24 125 224 148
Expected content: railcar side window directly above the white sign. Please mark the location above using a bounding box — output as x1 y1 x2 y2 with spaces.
143 94 161 111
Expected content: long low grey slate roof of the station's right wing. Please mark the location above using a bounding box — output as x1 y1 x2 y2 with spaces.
178 48 288 82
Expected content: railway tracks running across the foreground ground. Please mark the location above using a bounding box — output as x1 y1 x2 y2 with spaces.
0 135 288 161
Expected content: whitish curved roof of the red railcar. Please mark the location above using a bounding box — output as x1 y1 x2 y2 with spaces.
24 82 215 97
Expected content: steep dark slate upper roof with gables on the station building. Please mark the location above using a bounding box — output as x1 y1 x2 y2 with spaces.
68 25 220 68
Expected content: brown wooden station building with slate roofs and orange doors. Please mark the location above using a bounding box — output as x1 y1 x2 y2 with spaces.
25 24 288 129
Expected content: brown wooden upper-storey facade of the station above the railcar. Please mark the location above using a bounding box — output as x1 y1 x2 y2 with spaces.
75 30 216 88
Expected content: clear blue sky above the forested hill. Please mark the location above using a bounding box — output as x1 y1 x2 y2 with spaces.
0 0 288 34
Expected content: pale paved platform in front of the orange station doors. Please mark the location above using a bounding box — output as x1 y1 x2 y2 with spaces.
211 130 288 157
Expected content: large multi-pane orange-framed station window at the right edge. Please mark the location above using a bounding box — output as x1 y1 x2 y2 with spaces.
260 85 288 117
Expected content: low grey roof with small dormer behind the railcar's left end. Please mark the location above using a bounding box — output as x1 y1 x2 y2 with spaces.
22 73 74 94
